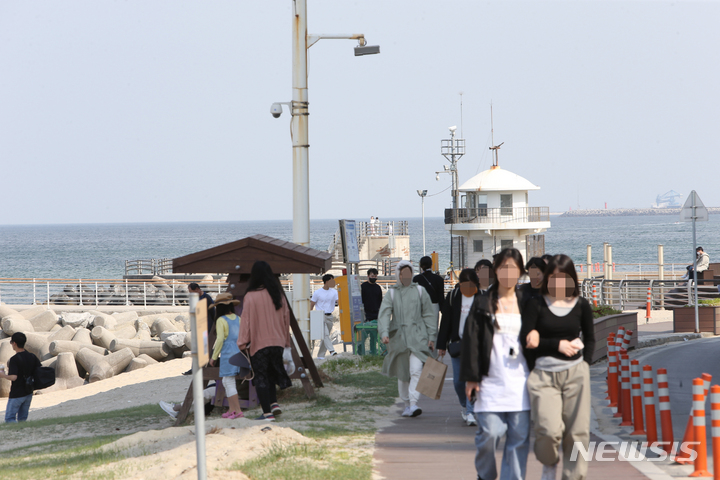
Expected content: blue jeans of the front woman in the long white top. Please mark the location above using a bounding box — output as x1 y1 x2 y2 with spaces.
475 410 530 480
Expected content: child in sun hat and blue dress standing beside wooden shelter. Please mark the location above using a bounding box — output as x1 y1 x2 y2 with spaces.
210 292 245 418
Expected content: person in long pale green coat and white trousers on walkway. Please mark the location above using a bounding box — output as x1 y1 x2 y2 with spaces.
378 260 437 417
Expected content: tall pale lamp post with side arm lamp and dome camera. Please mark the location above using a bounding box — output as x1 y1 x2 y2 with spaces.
270 0 380 340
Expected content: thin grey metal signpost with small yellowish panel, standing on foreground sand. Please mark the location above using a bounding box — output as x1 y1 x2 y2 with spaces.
188 293 208 480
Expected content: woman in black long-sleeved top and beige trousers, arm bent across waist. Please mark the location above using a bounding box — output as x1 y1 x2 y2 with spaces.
523 255 595 480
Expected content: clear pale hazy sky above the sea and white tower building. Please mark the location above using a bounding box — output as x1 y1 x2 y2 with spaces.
0 0 720 225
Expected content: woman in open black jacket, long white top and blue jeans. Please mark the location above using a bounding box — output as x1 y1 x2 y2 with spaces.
460 248 530 480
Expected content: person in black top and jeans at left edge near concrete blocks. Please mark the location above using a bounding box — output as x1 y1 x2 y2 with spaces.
0 332 41 423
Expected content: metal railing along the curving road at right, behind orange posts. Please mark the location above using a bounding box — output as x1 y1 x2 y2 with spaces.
580 278 720 310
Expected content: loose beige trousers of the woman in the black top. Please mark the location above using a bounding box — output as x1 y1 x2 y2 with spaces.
527 362 590 480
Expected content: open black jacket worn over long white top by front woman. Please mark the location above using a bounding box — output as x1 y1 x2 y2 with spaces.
460 293 535 382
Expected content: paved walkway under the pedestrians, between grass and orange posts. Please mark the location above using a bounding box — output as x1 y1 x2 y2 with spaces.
375 359 647 480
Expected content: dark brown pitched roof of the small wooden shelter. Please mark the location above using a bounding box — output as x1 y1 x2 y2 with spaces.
173 235 332 274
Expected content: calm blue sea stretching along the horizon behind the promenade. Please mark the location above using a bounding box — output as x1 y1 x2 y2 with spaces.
0 215 720 279
